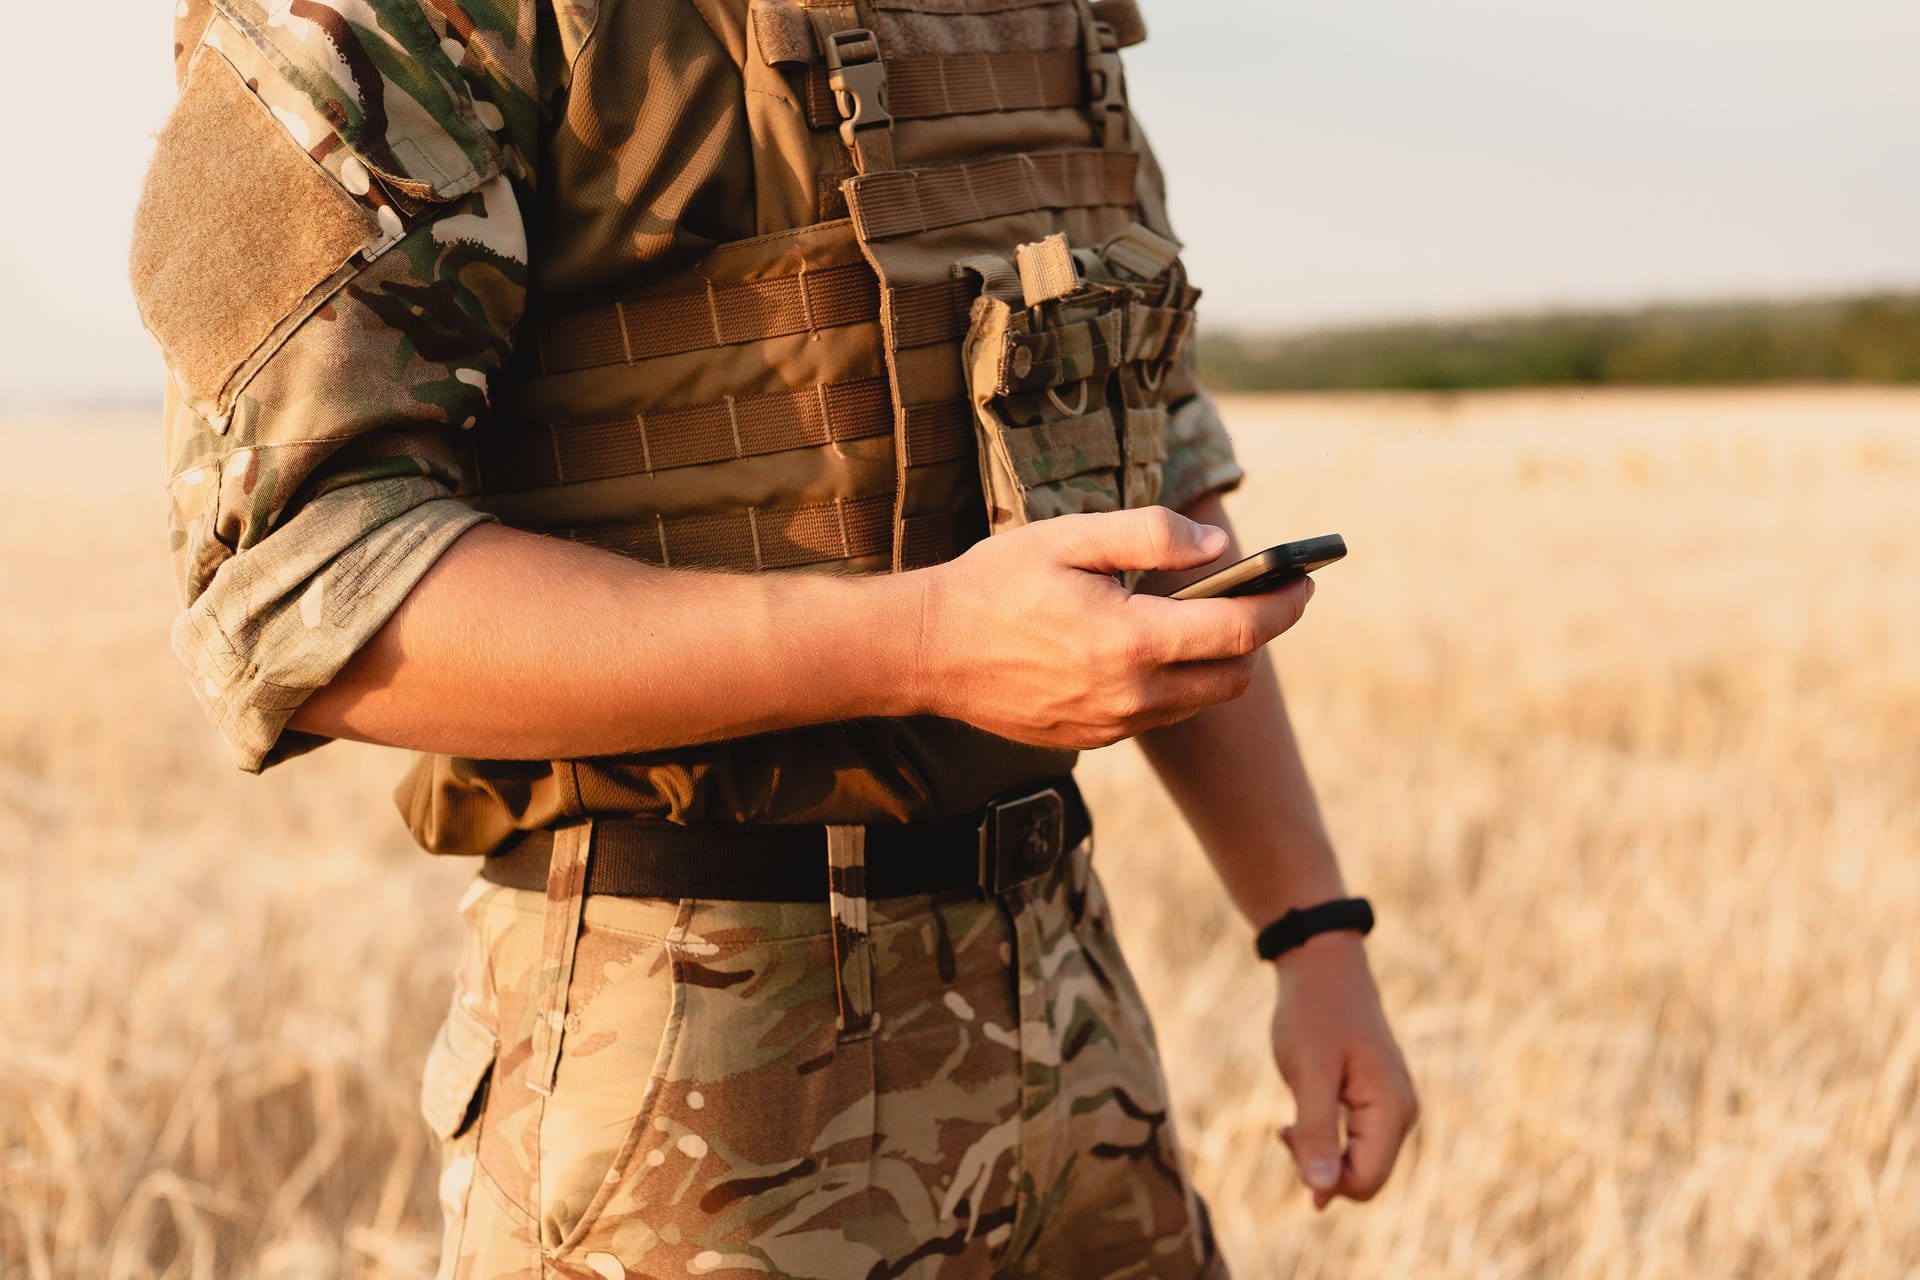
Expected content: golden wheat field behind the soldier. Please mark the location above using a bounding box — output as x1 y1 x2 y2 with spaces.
0 390 1920 1280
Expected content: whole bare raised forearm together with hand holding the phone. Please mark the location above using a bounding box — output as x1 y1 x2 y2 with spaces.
292 509 1306 760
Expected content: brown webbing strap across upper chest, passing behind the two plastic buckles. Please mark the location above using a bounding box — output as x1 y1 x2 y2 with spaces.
806 48 1087 129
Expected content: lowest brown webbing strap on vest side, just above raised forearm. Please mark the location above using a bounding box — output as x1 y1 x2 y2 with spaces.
553 493 973 572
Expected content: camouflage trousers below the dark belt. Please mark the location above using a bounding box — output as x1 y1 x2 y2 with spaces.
422 842 1225 1280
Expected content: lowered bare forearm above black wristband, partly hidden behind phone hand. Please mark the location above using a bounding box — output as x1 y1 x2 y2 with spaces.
1139 495 1346 927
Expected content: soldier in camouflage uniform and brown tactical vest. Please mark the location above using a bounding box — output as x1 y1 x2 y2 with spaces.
132 0 1413 1278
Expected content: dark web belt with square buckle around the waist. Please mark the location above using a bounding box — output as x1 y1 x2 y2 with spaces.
480 777 1092 902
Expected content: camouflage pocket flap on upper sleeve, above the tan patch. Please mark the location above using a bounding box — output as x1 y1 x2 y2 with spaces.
213 0 499 201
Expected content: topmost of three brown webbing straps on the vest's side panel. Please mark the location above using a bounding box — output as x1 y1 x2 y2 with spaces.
532 263 879 374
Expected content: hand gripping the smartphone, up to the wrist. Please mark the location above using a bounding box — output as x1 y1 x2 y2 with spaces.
916 507 1313 747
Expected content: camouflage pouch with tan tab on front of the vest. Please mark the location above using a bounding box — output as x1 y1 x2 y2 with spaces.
958 226 1198 533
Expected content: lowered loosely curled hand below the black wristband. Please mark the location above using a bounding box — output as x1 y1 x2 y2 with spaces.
1273 933 1421 1209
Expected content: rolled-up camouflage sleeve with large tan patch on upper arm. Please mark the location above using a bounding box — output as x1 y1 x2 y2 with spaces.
132 0 530 771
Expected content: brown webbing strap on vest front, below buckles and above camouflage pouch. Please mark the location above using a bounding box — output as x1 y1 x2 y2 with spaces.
851 150 1139 240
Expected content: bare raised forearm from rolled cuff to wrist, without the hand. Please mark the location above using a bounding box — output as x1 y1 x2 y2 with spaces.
292 524 920 760
